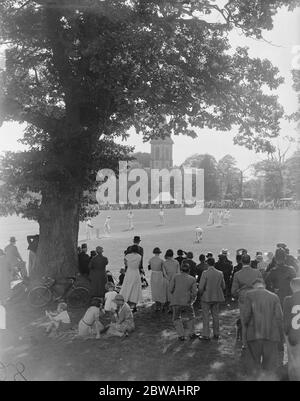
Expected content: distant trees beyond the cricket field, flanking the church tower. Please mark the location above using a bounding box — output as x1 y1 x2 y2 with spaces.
130 148 300 202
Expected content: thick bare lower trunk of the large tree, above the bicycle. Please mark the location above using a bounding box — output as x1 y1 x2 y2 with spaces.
34 191 80 278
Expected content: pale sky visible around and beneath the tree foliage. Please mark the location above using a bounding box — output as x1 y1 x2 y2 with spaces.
0 4 300 173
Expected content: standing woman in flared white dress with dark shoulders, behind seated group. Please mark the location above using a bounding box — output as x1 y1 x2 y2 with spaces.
120 245 143 312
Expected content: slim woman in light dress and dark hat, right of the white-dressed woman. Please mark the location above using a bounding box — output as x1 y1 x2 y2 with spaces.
148 248 167 311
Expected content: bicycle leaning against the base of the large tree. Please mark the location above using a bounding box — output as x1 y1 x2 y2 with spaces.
28 277 90 309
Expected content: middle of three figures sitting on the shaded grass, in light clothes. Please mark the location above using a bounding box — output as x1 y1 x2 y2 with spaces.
78 297 105 339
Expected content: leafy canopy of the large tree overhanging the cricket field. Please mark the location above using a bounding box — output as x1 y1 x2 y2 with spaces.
0 0 298 215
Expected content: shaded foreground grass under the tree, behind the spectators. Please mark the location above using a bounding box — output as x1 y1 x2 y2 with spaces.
2 305 246 381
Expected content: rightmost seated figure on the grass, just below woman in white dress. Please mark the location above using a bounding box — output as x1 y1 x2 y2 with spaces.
107 294 135 337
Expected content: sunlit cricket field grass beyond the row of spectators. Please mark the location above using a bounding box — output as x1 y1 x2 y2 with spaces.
0 209 300 280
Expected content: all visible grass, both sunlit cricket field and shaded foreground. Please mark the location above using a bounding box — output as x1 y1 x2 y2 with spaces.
0 209 300 381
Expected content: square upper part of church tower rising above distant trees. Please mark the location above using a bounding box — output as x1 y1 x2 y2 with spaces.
150 137 174 170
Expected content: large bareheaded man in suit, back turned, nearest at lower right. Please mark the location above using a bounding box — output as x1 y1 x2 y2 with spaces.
244 278 284 373
